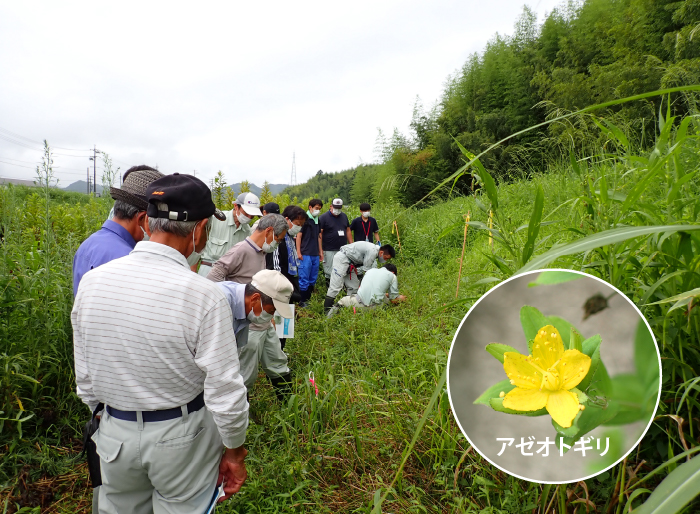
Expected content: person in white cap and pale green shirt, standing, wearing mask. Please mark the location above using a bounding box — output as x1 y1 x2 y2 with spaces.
197 193 263 277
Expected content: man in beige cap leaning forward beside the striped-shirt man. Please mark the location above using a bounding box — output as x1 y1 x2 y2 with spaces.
217 270 294 401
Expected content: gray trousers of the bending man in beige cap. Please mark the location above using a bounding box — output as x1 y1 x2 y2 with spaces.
238 325 289 391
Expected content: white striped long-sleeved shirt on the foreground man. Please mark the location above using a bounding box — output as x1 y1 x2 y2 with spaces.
71 241 248 448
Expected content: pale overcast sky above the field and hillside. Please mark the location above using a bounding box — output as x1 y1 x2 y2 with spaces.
0 0 560 187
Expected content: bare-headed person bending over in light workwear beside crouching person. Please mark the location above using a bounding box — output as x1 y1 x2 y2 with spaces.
323 241 396 314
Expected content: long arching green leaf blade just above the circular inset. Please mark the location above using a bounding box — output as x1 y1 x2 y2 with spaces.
515 225 700 275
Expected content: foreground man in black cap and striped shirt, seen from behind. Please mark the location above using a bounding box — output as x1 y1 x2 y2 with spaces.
71 173 248 513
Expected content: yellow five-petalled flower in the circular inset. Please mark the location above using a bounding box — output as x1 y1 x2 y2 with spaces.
503 325 591 428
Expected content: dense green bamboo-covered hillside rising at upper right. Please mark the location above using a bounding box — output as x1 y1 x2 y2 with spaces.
296 0 700 205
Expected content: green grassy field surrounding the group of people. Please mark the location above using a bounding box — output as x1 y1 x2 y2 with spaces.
0 110 700 514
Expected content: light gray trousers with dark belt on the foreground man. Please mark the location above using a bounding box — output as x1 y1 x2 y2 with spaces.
92 407 224 508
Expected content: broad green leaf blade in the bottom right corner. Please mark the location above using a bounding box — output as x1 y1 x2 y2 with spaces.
632 457 700 514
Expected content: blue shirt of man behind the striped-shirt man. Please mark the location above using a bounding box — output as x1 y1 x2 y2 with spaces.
73 220 136 296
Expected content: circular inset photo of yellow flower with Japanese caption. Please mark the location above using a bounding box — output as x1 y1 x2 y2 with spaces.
447 270 661 484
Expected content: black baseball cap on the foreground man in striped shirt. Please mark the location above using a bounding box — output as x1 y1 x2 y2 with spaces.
146 173 226 221
